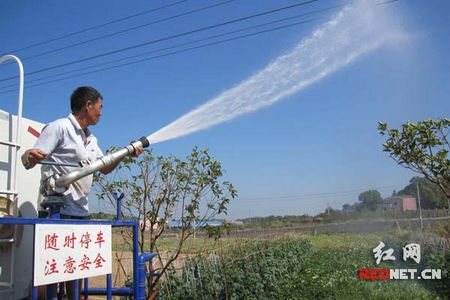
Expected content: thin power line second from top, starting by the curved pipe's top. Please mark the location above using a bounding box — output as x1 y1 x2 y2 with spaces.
22 0 239 61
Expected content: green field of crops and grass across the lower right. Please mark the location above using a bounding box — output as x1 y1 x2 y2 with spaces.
154 231 450 299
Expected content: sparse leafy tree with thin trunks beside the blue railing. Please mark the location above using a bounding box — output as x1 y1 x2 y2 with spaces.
95 148 237 297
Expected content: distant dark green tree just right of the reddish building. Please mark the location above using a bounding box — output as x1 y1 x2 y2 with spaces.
398 177 447 209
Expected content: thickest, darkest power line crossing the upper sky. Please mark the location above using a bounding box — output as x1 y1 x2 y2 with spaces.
0 0 318 82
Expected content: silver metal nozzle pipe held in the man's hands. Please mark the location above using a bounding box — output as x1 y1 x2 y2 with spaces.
55 137 150 187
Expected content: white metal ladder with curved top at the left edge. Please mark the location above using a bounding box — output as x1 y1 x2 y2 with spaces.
0 55 24 292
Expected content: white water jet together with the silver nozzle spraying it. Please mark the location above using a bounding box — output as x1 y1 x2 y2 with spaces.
35 1 403 197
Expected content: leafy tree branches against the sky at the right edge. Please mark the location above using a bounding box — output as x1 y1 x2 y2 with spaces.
378 118 450 213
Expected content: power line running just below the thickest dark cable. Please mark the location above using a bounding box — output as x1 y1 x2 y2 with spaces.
0 5 342 89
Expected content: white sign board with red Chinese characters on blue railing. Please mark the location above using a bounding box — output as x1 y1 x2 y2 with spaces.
34 224 112 286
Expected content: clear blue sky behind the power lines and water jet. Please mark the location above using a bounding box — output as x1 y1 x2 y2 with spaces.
0 0 450 219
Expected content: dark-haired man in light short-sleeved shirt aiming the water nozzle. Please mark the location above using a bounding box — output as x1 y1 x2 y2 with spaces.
22 86 143 219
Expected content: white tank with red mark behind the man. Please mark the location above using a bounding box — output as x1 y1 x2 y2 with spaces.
0 110 44 300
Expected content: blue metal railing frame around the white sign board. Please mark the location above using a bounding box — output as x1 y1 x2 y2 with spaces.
0 193 157 300
